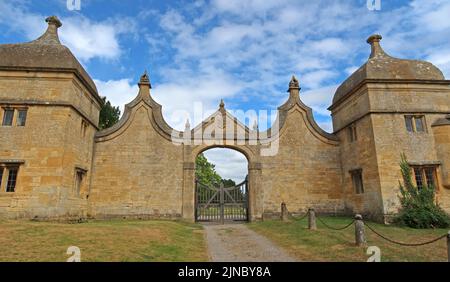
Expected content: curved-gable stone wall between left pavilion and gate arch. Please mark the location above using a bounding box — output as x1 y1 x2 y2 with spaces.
89 87 183 218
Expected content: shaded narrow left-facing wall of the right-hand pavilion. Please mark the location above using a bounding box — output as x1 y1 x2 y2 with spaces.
332 87 383 219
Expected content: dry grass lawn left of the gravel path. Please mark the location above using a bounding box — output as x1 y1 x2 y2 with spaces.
0 220 208 262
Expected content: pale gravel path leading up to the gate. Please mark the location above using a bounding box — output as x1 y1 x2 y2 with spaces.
203 224 296 262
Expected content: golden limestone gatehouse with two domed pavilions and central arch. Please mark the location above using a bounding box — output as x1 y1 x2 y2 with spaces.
0 17 450 221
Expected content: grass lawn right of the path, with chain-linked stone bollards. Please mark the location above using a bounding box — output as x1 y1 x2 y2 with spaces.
248 217 448 262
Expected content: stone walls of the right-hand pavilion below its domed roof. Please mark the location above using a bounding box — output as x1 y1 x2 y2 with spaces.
332 82 450 218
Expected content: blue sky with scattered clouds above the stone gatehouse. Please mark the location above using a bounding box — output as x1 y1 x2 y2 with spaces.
0 0 450 181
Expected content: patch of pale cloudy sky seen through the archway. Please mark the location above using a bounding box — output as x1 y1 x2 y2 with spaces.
204 148 248 184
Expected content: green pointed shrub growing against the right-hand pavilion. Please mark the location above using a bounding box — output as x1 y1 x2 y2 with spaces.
395 154 450 228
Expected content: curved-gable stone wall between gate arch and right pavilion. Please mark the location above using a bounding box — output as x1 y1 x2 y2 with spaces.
261 105 344 215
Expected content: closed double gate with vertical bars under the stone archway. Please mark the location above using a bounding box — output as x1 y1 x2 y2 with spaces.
195 177 248 223
